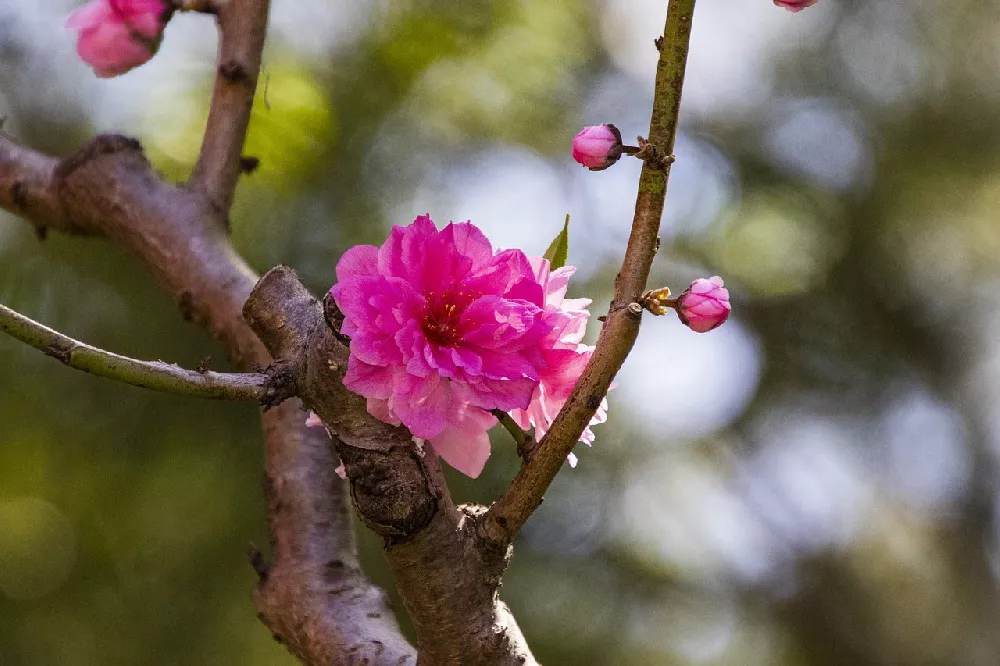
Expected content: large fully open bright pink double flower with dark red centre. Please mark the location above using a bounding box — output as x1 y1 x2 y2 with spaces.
330 215 553 477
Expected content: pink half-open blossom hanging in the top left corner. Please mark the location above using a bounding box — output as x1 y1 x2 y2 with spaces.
66 0 171 78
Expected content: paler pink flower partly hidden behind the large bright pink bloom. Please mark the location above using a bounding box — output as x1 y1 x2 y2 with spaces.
510 257 608 465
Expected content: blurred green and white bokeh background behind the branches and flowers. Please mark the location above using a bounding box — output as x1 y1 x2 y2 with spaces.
0 0 1000 666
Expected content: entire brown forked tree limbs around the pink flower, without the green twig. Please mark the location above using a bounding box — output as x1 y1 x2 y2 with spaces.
0 0 695 666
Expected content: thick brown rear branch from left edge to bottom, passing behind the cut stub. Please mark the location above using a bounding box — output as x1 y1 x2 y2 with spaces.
0 135 415 666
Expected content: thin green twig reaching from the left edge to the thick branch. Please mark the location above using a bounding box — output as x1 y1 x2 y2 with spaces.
0 304 267 402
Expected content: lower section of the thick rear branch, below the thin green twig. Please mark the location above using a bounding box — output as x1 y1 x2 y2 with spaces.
254 400 416 666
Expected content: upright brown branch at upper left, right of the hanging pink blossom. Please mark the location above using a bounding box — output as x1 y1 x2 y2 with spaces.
189 0 269 213
